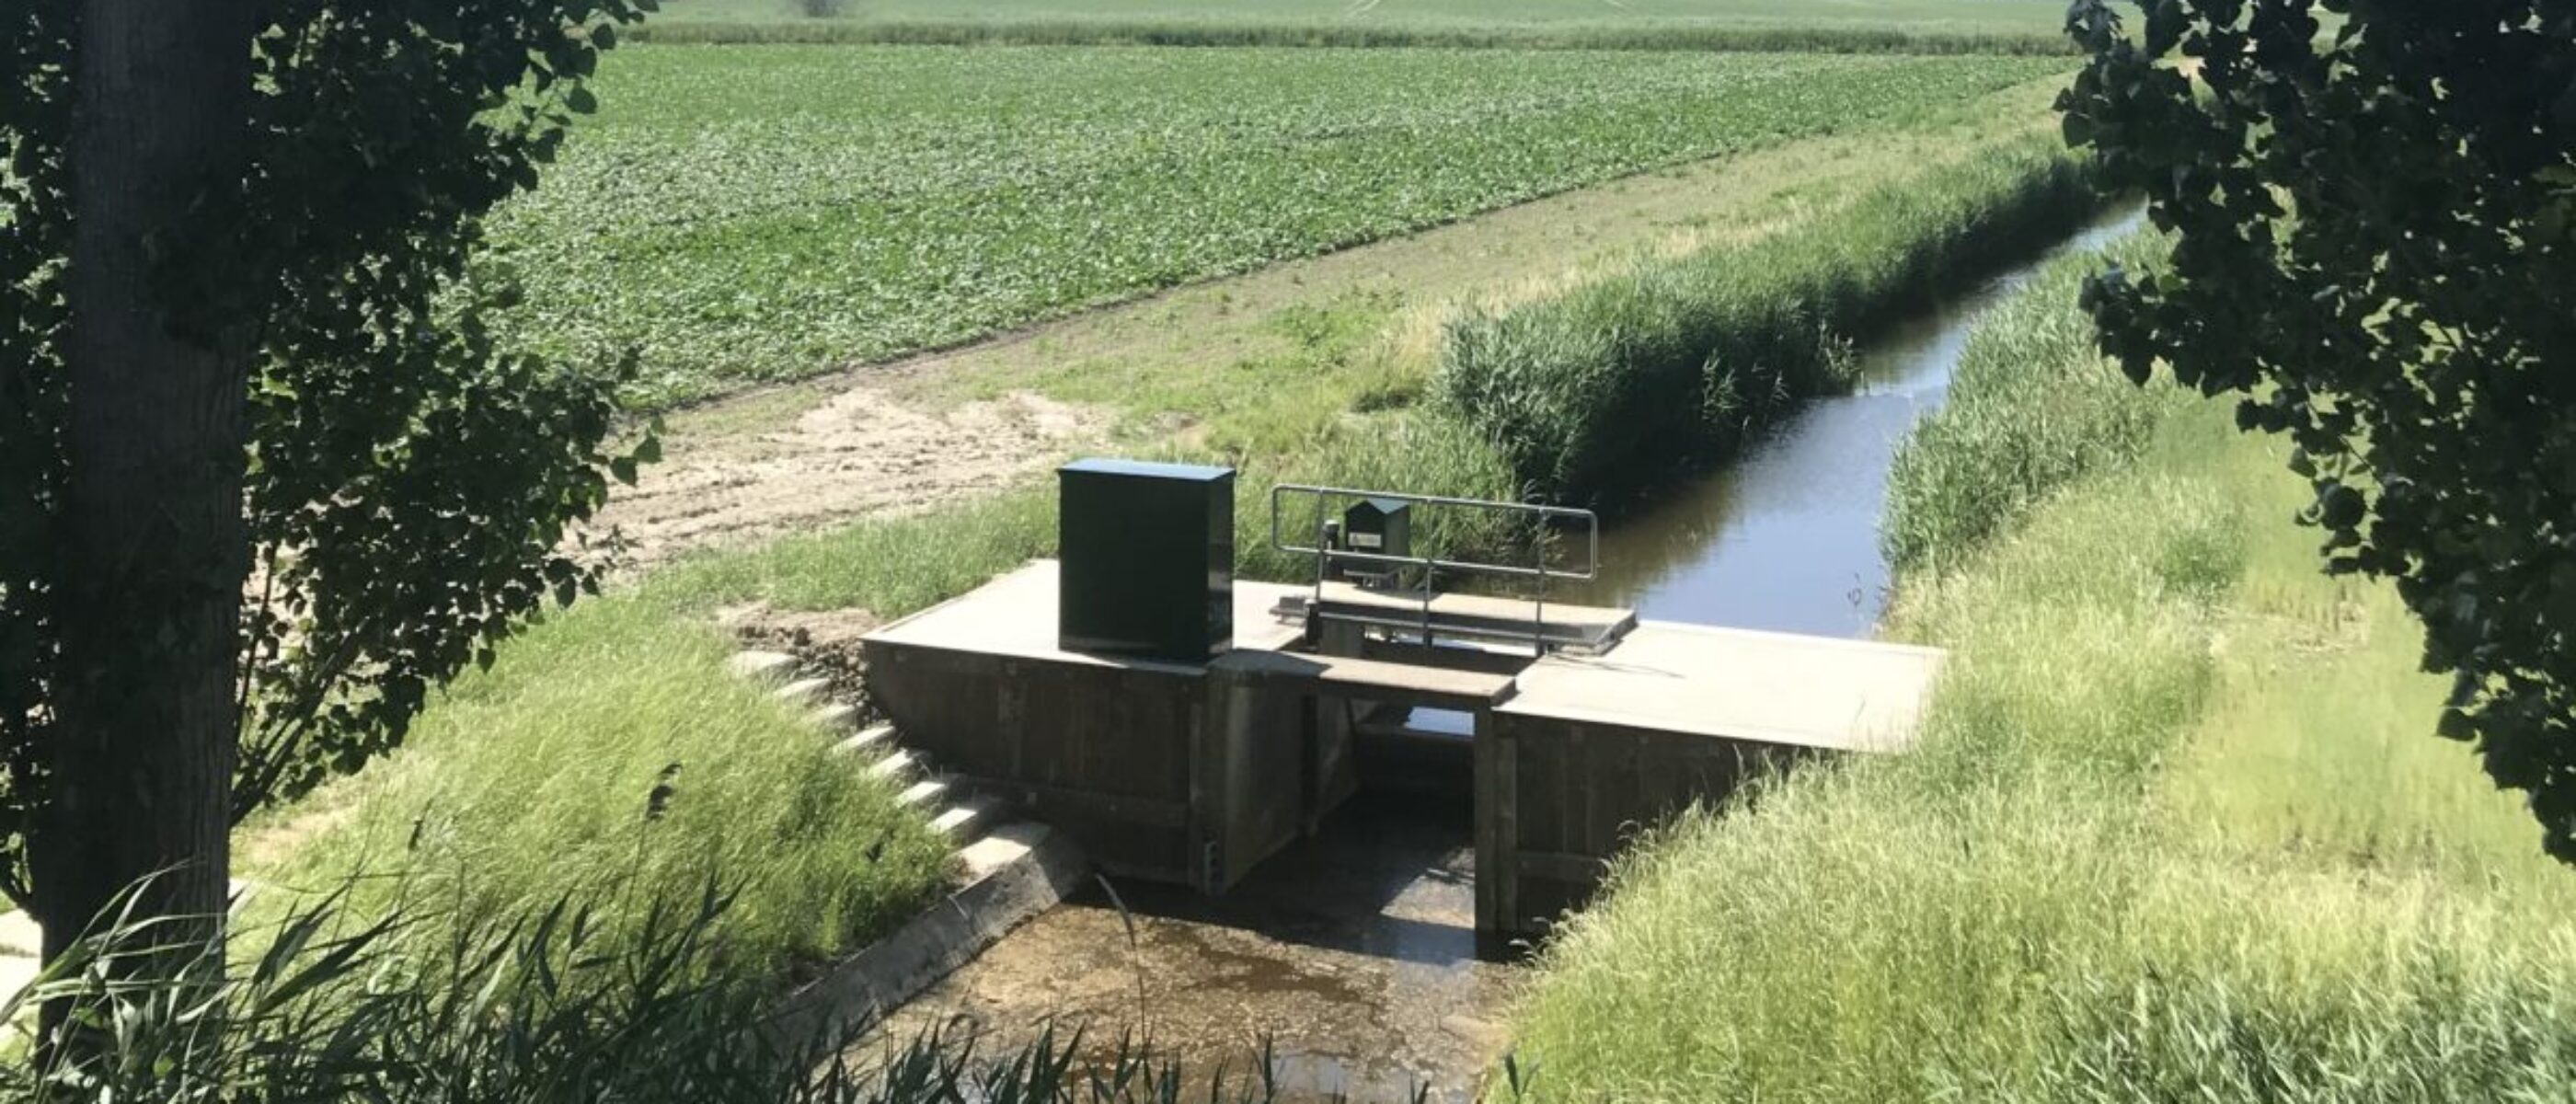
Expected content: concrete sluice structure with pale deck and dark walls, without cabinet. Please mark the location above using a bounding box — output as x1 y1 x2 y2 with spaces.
866 561 1942 955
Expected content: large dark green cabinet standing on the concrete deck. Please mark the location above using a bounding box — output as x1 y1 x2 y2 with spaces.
1056 458 1234 664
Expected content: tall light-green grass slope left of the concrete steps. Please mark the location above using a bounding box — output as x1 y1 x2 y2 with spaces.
242 594 950 985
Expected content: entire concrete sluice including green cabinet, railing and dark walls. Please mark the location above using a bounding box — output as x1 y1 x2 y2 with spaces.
863 461 1942 955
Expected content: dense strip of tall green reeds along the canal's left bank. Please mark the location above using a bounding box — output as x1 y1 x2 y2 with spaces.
1435 139 2097 501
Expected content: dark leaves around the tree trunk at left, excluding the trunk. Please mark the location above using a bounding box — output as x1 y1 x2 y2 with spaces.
0 0 651 901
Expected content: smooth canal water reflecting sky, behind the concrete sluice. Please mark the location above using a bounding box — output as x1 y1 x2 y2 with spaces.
1551 211 2141 636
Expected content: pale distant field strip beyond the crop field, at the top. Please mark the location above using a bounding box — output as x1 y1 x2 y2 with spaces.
644 0 2071 54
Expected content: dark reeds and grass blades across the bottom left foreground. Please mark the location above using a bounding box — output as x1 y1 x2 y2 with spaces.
0 885 1328 1104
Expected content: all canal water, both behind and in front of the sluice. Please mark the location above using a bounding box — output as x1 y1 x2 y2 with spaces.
855 204 2138 1098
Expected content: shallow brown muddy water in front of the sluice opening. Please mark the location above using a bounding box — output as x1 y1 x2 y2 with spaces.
881 795 1517 1101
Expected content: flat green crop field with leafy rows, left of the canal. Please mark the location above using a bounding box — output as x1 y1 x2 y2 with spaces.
495 46 2064 404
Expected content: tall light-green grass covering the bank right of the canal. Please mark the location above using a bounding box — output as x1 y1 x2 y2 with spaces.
1517 230 2576 1101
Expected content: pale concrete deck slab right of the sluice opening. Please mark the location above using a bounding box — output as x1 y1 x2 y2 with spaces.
1494 620 1942 752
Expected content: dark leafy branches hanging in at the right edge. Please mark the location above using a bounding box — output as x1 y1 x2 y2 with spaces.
2064 0 2576 862
